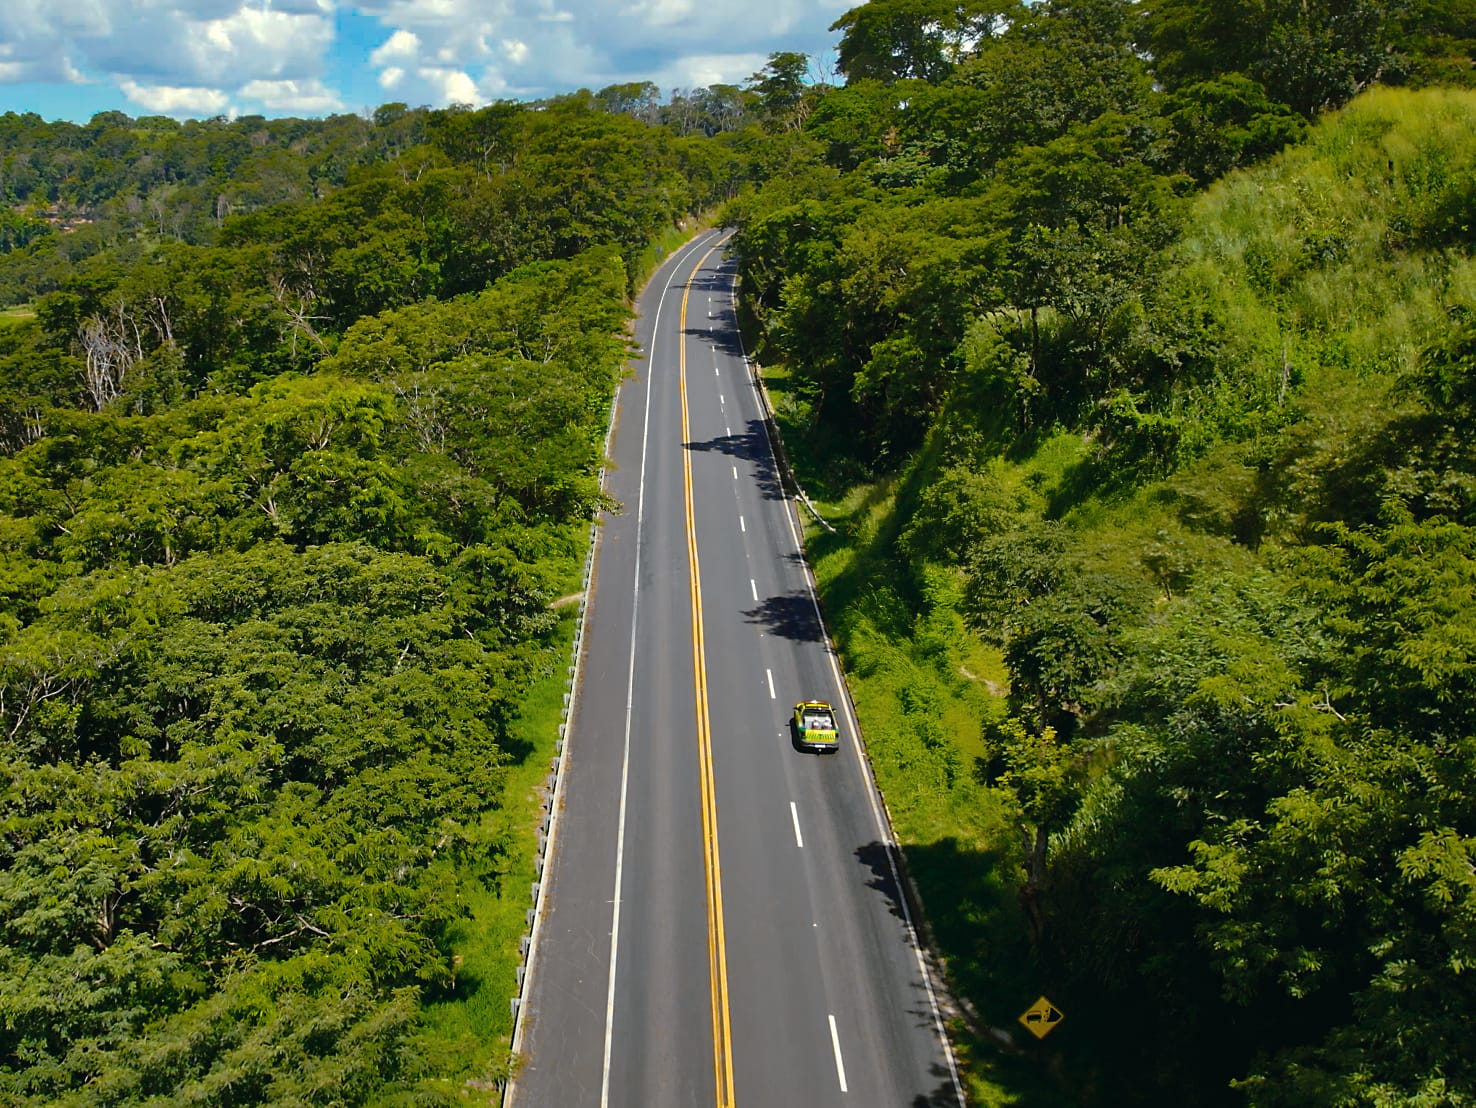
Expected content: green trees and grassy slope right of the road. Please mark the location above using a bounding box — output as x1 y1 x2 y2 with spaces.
728 0 1476 1105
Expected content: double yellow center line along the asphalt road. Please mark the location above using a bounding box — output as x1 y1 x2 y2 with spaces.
679 245 734 1108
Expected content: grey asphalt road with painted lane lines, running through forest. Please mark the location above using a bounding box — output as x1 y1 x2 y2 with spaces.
506 233 962 1108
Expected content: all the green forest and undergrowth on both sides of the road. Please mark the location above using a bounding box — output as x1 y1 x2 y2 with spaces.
0 0 1476 1105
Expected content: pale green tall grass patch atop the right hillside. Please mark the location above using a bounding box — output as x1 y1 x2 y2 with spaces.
1162 89 1476 453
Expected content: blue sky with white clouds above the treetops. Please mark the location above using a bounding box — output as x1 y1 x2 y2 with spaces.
0 0 858 122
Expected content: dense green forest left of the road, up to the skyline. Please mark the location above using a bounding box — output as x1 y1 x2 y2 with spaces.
0 86 754 1105
